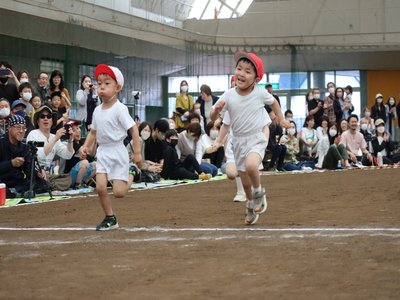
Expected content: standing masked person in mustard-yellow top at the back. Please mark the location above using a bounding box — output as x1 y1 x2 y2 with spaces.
175 80 194 132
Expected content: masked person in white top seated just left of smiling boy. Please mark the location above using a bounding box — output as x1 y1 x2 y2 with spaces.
197 121 226 168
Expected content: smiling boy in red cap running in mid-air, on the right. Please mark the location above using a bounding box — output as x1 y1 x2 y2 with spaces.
211 51 289 225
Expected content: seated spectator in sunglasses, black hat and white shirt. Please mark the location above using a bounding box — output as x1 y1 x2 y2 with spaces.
26 105 74 170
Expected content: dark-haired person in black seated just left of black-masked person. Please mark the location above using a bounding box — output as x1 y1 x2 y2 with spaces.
144 118 169 165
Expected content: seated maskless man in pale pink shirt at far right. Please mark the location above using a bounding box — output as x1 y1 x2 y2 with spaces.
340 114 373 166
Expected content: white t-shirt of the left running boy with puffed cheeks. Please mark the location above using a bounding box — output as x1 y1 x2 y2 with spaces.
92 100 136 145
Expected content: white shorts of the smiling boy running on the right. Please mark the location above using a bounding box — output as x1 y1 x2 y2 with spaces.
233 132 268 172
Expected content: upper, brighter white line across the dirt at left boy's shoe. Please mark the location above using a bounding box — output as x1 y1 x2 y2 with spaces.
0 226 400 233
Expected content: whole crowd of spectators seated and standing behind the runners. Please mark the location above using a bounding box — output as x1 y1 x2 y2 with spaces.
0 61 400 197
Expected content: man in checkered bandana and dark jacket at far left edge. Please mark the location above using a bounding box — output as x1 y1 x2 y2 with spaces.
0 115 45 198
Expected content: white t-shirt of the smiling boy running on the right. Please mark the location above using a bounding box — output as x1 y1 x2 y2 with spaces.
220 86 275 137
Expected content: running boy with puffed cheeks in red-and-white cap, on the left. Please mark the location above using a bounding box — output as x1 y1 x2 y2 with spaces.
79 64 142 231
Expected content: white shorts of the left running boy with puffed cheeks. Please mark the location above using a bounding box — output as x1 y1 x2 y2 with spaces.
96 143 129 182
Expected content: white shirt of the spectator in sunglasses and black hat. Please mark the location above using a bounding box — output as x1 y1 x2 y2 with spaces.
26 129 74 168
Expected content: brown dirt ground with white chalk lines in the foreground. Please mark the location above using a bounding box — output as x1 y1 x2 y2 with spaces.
0 169 400 300
